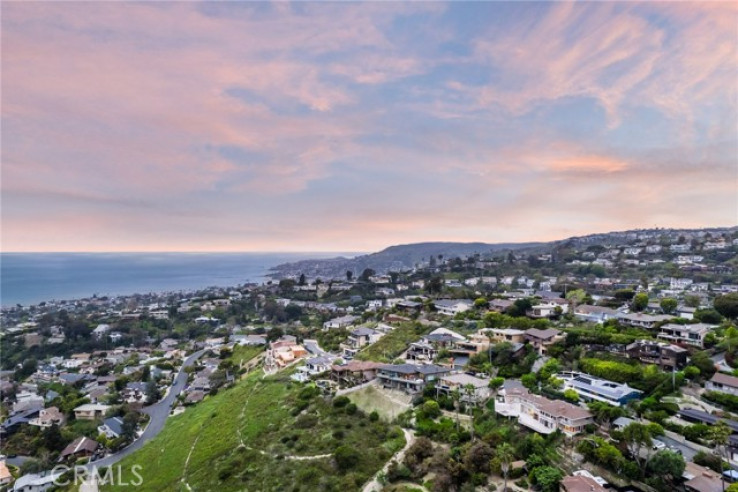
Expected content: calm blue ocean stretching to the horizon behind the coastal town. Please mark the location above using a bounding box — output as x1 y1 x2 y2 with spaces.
0 253 356 307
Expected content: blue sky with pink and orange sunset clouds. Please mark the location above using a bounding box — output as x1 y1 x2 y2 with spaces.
0 1 738 252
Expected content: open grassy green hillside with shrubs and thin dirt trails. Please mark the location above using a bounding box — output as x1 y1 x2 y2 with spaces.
103 364 404 491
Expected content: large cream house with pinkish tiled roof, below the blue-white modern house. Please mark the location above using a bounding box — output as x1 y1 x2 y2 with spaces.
495 387 594 436
